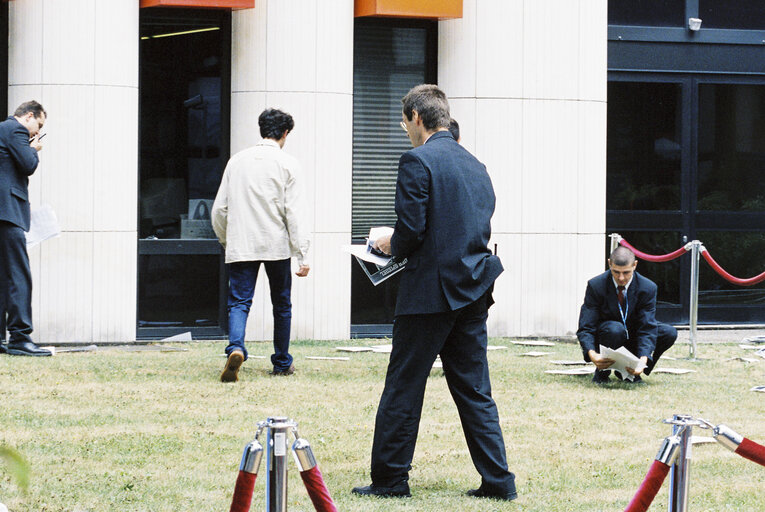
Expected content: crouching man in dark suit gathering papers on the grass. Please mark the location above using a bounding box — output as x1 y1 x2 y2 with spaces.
576 246 677 384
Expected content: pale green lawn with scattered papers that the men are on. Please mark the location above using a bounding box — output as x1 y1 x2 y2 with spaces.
0 339 765 512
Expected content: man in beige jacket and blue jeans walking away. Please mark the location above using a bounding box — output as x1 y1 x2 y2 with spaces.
212 108 310 382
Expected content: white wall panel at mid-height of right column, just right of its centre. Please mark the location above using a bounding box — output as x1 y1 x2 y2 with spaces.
523 100 579 233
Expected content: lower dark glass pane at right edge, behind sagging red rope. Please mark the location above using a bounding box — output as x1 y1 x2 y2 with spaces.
698 231 765 305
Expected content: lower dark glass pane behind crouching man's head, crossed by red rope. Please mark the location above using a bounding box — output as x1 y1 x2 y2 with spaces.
606 231 687 305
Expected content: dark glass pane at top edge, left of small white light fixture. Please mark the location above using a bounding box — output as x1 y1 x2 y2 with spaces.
608 0 688 27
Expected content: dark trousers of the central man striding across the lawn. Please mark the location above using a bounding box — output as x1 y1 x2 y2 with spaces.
372 295 515 494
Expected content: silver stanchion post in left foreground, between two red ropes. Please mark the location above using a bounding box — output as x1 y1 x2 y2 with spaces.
266 416 297 512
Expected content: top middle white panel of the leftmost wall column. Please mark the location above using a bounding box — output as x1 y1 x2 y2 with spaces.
37 0 94 84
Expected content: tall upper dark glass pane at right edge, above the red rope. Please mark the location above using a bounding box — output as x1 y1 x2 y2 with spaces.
697 84 765 211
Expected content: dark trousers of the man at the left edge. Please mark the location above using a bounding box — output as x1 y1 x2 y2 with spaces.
0 221 32 343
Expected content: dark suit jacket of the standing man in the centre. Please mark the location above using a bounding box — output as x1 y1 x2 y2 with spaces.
391 131 503 315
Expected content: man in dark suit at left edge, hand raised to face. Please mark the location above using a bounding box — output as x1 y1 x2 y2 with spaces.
0 101 51 356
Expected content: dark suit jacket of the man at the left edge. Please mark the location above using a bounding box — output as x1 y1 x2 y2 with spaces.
0 116 40 231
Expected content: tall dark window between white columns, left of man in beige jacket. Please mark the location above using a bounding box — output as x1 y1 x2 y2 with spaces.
138 8 231 337
